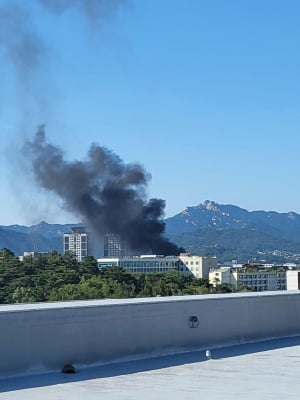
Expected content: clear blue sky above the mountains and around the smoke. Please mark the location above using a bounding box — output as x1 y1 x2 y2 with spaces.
0 0 300 225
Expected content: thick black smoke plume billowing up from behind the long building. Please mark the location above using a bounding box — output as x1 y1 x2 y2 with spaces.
24 127 184 255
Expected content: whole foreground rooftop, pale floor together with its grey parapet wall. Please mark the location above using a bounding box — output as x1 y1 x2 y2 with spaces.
0 291 300 400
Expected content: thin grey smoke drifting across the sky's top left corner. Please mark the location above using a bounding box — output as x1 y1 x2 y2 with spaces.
0 0 126 88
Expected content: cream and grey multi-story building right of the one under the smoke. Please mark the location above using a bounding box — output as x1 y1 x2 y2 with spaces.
209 266 287 292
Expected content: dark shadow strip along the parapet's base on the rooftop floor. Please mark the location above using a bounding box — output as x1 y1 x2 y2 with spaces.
0 336 300 393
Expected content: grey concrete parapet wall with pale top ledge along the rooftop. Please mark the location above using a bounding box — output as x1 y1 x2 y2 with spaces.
0 292 300 376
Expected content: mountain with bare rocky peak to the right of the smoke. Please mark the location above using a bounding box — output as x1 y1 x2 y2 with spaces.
165 200 300 262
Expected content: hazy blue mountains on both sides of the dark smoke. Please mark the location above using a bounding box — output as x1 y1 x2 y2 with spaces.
0 200 300 262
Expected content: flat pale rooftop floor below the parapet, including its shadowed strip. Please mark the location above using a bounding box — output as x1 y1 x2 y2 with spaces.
0 336 300 400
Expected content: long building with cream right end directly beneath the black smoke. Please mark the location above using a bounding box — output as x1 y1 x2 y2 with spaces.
97 253 217 278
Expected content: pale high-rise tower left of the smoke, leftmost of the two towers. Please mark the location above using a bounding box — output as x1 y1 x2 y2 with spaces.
63 226 93 262
